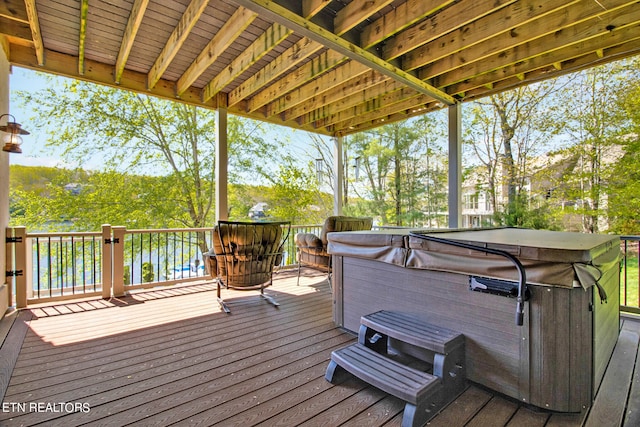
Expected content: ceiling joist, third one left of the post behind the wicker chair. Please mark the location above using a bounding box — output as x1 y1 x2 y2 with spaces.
147 0 209 89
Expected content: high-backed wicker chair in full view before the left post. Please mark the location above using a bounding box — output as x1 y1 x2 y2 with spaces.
206 221 291 313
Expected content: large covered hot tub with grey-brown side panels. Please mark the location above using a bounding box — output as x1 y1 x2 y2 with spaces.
328 228 620 412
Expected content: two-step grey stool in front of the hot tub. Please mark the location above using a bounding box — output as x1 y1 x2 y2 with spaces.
325 311 465 427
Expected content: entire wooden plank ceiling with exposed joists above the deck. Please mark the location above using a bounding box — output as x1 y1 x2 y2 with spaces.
0 0 640 135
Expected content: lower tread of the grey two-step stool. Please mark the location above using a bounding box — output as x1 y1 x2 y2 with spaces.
331 343 441 405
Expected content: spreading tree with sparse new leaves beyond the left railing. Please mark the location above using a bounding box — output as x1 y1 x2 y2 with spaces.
19 80 278 244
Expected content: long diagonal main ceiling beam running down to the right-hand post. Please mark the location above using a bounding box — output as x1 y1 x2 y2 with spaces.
236 0 456 105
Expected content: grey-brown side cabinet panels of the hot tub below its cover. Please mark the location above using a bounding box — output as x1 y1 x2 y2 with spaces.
329 230 619 412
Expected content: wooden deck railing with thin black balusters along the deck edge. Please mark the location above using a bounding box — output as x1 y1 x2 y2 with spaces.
7 225 640 314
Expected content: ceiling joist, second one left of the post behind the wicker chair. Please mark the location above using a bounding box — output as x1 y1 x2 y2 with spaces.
176 7 258 96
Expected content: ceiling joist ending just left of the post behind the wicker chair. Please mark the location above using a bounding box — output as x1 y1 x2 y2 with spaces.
202 24 293 101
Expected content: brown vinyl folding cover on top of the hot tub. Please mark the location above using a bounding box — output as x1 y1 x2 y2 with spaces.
329 228 620 289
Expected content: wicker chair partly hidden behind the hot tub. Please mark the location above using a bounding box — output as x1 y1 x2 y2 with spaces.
295 216 373 285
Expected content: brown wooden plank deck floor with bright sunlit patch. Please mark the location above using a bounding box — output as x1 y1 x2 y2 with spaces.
0 272 640 427
